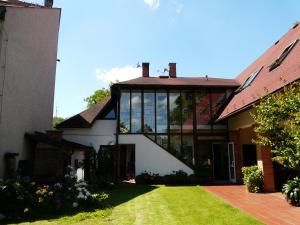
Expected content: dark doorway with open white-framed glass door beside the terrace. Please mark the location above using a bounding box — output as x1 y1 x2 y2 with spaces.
213 143 236 182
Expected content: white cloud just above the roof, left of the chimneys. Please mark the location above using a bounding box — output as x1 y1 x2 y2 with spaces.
96 66 142 83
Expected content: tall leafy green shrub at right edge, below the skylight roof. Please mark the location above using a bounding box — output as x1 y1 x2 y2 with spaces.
252 82 300 169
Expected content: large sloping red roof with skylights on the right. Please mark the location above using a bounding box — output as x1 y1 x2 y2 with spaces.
218 24 300 120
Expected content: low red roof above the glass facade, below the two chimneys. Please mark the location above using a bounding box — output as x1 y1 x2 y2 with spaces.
115 77 239 87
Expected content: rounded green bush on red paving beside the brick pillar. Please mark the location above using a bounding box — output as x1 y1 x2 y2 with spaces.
242 166 264 193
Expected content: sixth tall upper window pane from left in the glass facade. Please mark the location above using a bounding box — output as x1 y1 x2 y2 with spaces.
181 92 194 133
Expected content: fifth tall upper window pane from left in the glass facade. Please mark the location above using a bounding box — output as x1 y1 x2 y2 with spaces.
169 92 181 133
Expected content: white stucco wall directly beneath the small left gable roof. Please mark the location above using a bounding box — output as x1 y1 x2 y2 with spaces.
63 120 117 151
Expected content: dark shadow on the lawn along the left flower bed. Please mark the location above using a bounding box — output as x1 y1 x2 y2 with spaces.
0 184 157 224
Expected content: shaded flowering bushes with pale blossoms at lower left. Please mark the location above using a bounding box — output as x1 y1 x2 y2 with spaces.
0 167 108 219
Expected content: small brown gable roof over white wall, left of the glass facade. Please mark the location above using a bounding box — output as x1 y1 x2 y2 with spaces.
56 97 111 128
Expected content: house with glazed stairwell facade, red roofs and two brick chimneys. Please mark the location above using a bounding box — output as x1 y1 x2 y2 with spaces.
58 23 300 191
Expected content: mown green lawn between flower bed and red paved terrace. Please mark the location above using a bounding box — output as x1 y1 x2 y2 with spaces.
12 186 262 225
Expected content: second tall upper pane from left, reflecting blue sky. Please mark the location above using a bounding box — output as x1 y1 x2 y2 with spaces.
131 91 142 133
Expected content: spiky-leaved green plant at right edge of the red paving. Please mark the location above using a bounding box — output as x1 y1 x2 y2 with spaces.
282 177 300 206
